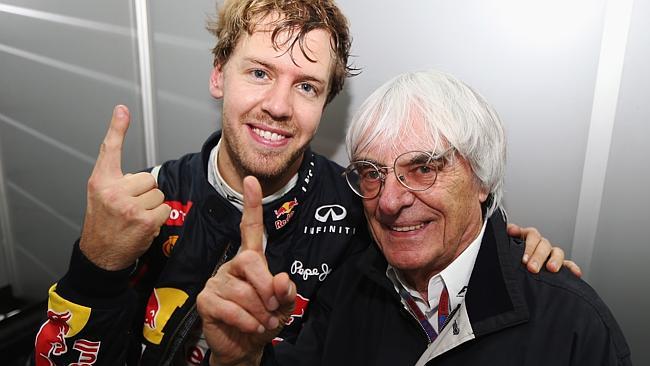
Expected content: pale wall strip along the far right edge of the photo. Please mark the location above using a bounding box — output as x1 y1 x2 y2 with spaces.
589 0 650 365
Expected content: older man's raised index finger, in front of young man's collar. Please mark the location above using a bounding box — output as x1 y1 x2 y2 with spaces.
239 176 264 255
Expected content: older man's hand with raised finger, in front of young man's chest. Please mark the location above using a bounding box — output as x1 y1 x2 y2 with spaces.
197 177 296 365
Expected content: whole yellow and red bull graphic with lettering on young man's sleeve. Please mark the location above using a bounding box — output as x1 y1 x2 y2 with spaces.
34 284 93 366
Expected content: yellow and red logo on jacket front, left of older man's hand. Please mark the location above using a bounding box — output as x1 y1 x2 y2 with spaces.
142 287 189 344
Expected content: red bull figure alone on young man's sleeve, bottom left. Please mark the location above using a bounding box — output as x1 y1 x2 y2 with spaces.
35 310 72 366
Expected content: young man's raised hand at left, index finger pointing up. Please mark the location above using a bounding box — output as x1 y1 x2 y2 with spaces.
79 105 171 270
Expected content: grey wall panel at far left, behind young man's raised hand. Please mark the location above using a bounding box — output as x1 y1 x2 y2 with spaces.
0 0 144 300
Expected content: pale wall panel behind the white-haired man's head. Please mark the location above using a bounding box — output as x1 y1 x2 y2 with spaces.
326 0 604 251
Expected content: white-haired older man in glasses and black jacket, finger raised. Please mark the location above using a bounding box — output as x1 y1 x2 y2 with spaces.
199 71 630 366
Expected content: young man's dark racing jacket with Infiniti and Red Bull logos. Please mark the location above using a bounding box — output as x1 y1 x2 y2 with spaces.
35 133 368 365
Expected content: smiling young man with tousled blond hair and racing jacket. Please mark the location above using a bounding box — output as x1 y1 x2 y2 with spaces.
35 0 563 365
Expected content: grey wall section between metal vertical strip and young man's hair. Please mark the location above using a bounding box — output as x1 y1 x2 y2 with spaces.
151 0 215 161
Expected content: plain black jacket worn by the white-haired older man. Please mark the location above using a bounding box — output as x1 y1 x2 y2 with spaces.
264 212 631 366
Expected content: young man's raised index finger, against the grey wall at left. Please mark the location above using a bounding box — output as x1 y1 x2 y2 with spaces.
93 105 129 178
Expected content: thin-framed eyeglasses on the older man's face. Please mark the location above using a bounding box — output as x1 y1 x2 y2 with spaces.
343 147 456 199
